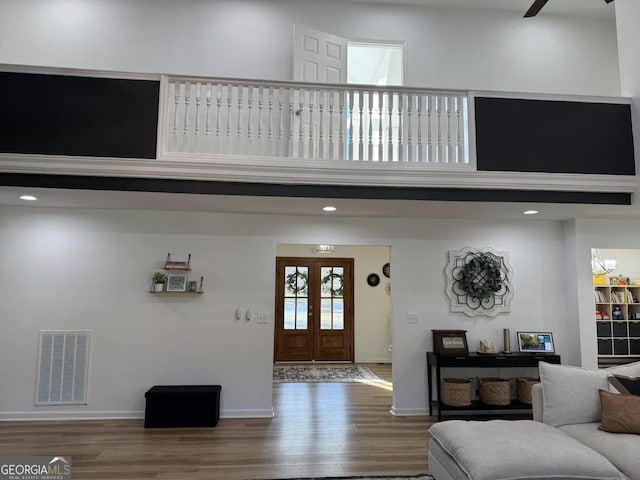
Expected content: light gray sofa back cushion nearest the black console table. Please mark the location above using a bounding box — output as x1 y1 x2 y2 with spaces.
539 362 608 427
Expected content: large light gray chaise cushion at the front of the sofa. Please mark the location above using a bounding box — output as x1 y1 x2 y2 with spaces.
429 420 624 480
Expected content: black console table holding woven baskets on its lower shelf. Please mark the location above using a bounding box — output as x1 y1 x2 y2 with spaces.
427 352 560 421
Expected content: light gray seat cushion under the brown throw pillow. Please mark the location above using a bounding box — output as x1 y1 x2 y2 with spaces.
558 422 640 480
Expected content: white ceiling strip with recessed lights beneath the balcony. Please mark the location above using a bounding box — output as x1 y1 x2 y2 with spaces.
0 187 640 220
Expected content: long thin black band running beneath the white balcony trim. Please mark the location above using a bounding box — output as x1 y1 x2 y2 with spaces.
0 173 631 205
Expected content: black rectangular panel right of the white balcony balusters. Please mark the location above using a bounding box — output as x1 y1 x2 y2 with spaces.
475 97 635 175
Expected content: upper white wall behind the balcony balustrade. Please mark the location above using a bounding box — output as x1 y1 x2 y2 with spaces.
0 0 620 95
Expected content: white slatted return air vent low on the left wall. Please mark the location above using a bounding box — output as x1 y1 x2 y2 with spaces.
36 331 91 405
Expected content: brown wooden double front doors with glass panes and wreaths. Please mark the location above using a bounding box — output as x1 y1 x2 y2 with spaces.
274 257 354 362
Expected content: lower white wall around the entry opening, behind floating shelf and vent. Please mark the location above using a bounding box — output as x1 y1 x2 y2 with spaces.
0 207 568 418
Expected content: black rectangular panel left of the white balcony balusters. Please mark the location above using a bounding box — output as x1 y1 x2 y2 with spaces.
0 72 160 158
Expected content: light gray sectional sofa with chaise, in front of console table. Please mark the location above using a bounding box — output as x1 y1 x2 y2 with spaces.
429 362 640 480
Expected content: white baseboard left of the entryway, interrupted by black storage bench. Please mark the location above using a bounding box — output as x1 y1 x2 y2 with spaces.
0 408 275 422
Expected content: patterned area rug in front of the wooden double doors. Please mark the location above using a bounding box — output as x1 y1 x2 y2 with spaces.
273 364 384 383
